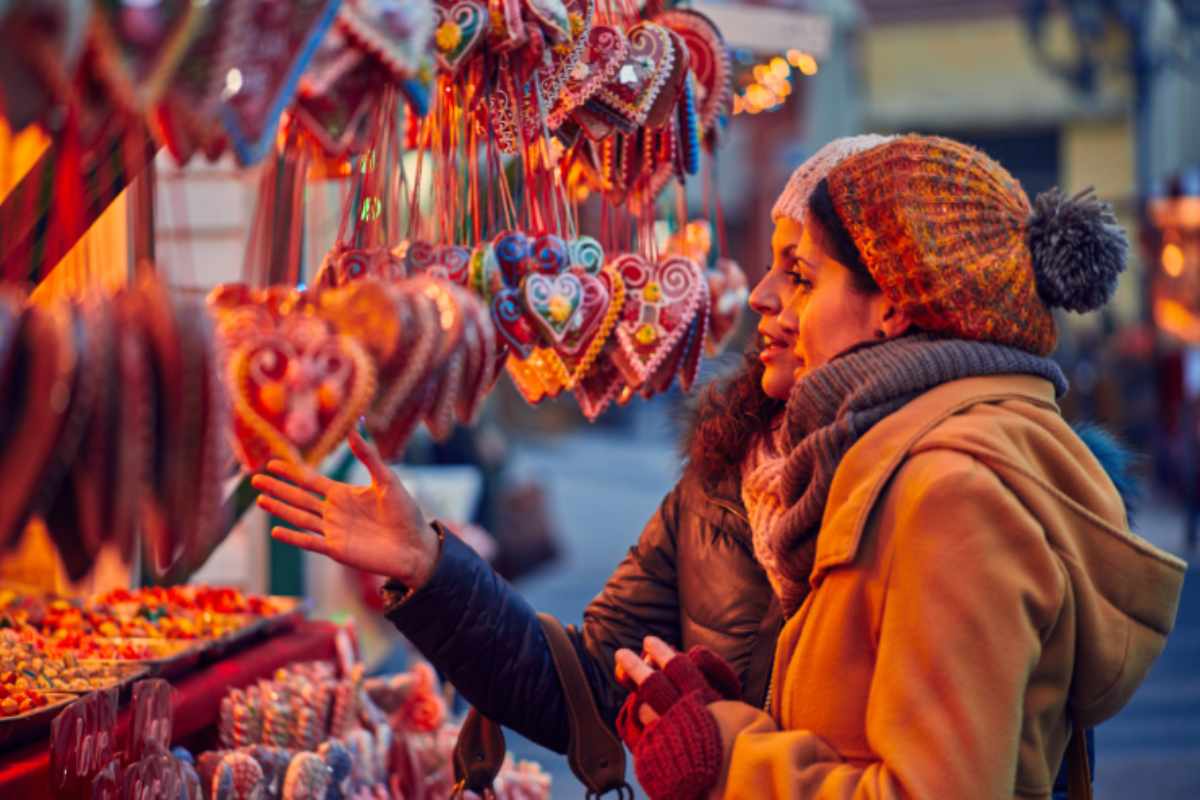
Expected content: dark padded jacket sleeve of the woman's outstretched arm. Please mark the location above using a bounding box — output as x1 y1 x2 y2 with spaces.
385 487 679 753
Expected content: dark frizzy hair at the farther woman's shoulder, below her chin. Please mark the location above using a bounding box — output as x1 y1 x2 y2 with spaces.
682 347 785 492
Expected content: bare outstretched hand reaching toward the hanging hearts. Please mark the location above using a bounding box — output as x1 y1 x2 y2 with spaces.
251 431 438 589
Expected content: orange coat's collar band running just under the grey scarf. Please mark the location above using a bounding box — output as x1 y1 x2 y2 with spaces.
811 375 1058 584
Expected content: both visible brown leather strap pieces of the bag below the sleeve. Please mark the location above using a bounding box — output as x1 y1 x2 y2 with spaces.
454 614 634 800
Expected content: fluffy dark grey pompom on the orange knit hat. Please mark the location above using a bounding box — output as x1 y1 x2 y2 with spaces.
1028 187 1129 313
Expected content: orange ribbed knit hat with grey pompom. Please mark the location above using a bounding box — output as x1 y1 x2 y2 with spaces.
826 136 1128 355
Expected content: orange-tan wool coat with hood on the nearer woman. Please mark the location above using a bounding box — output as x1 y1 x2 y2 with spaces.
709 375 1184 800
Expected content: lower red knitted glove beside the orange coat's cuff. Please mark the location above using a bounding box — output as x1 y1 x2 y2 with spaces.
634 692 721 800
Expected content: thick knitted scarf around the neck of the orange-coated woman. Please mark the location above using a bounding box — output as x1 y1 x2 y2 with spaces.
742 333 1067 615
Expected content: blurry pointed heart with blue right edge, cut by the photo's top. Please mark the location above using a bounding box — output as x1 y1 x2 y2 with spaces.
221 0 338 164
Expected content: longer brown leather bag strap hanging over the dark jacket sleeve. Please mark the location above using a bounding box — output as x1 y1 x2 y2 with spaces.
538 614 634 799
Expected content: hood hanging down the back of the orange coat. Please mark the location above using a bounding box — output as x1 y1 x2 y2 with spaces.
914 378 1187 726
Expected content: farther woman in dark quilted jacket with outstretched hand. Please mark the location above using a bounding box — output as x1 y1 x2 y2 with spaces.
254 137 1108 796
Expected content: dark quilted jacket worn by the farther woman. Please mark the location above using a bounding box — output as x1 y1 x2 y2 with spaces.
388 465 782 752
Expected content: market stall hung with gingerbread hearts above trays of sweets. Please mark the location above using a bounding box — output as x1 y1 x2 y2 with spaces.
0 0 830 800
